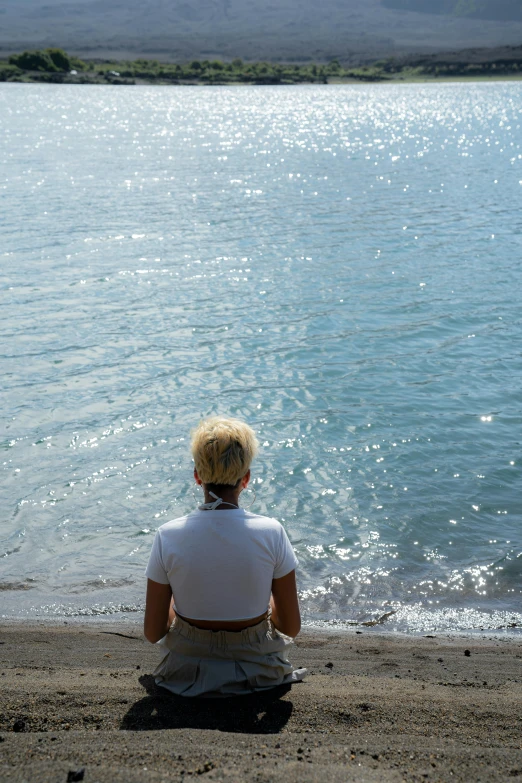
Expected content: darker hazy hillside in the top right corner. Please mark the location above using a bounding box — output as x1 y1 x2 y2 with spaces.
382 0 522 22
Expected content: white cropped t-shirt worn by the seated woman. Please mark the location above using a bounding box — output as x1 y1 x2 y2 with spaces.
145 508 298 621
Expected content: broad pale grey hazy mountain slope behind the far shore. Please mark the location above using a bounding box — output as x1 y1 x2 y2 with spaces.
0 0 522 63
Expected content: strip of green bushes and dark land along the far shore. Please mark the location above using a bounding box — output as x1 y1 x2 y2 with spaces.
0 48 522 84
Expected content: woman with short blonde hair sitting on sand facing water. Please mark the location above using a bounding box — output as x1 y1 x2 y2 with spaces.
144 417 306 696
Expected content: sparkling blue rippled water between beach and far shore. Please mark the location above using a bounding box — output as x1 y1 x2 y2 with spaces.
0 83 522 631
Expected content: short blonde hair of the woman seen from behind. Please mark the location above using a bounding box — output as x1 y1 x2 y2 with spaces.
192 416 259 486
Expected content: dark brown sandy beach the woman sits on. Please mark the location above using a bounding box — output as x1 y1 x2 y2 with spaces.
0 624 522 783
